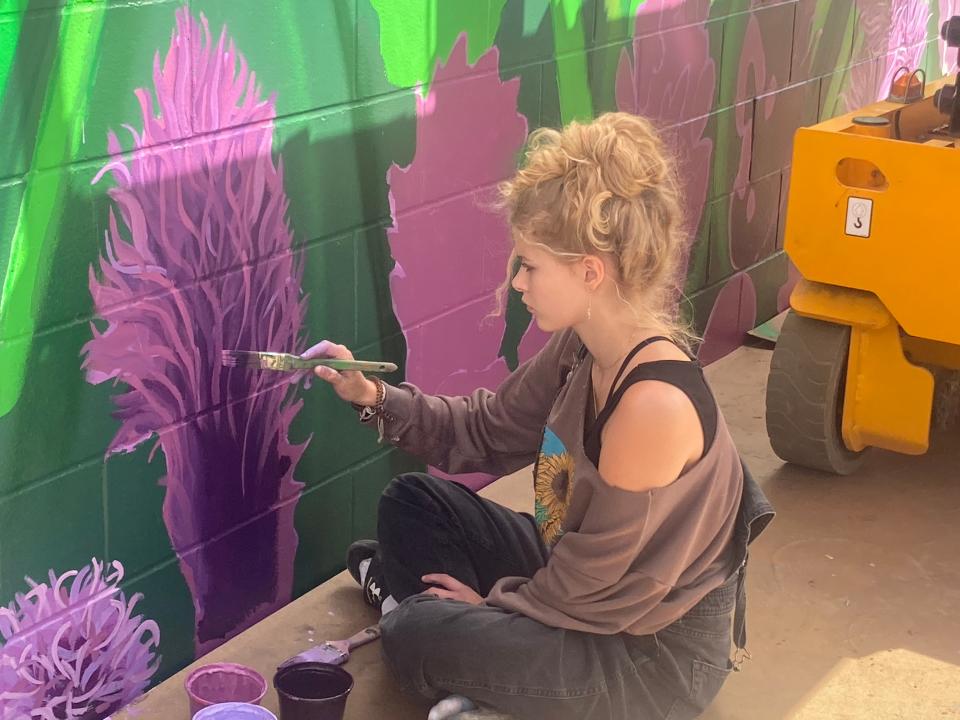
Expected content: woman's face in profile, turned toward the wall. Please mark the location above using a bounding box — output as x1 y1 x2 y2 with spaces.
511 240 588 332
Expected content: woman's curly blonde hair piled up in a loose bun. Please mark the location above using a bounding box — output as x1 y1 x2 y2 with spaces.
497 113 697 351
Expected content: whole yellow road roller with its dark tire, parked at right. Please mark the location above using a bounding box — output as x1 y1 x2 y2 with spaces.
766 17 960 474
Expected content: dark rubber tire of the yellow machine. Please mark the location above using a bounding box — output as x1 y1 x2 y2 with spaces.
767 310 864 475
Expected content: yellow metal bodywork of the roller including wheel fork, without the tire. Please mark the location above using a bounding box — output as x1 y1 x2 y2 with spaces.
784 78 960 454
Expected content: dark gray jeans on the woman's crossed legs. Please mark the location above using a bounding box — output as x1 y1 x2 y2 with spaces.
378 473 756 720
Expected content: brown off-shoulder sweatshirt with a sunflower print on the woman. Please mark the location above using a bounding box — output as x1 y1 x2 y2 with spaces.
372 330 743 635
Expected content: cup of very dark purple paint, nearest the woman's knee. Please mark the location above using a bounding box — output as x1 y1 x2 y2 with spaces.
273 662 353 720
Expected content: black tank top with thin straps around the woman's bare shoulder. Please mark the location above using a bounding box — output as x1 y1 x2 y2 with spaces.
583 335 718 467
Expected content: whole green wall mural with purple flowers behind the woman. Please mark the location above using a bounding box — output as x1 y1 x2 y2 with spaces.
0 0 960 720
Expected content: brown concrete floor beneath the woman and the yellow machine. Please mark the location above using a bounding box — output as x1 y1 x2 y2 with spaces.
116 348 960 720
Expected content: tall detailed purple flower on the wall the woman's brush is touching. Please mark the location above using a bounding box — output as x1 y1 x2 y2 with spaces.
84 8 305 654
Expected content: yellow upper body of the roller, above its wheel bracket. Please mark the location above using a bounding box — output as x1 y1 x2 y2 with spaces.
784 81 960 345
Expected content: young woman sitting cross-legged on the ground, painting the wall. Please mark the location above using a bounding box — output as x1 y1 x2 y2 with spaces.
308 113 772 720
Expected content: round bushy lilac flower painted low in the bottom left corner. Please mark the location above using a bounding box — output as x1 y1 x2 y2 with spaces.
0 559 160 720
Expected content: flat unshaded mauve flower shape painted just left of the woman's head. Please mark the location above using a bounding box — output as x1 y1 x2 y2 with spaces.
387 35 546 488
